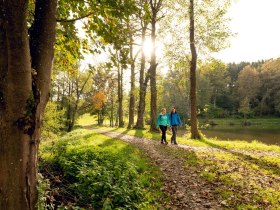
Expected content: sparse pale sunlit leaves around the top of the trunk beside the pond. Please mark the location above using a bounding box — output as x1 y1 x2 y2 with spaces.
162 0 233 60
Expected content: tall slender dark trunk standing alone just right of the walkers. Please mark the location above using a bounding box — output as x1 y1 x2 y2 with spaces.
189 0 200 139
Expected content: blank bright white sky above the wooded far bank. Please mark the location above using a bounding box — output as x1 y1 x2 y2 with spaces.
215 0 280 62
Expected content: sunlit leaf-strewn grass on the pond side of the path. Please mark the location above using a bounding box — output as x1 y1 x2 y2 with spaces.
79 115 280 209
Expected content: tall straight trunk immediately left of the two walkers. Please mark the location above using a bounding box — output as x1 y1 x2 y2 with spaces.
150 12 157 131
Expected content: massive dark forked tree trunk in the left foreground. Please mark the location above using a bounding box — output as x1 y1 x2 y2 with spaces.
0 0 56 210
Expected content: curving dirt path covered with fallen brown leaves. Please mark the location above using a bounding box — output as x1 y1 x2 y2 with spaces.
85 126 223 210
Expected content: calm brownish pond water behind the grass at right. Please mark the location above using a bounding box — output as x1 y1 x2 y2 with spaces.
178 126 280 145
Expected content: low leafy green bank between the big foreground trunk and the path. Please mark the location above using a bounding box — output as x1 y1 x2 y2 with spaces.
41 130 165 209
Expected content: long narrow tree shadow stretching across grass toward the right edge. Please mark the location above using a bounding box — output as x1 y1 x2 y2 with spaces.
199 139 280 176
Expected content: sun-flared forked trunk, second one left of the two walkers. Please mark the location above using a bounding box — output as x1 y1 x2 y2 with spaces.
135 24 149 129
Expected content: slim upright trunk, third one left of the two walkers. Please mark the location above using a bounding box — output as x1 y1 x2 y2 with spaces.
127 35 135 128
